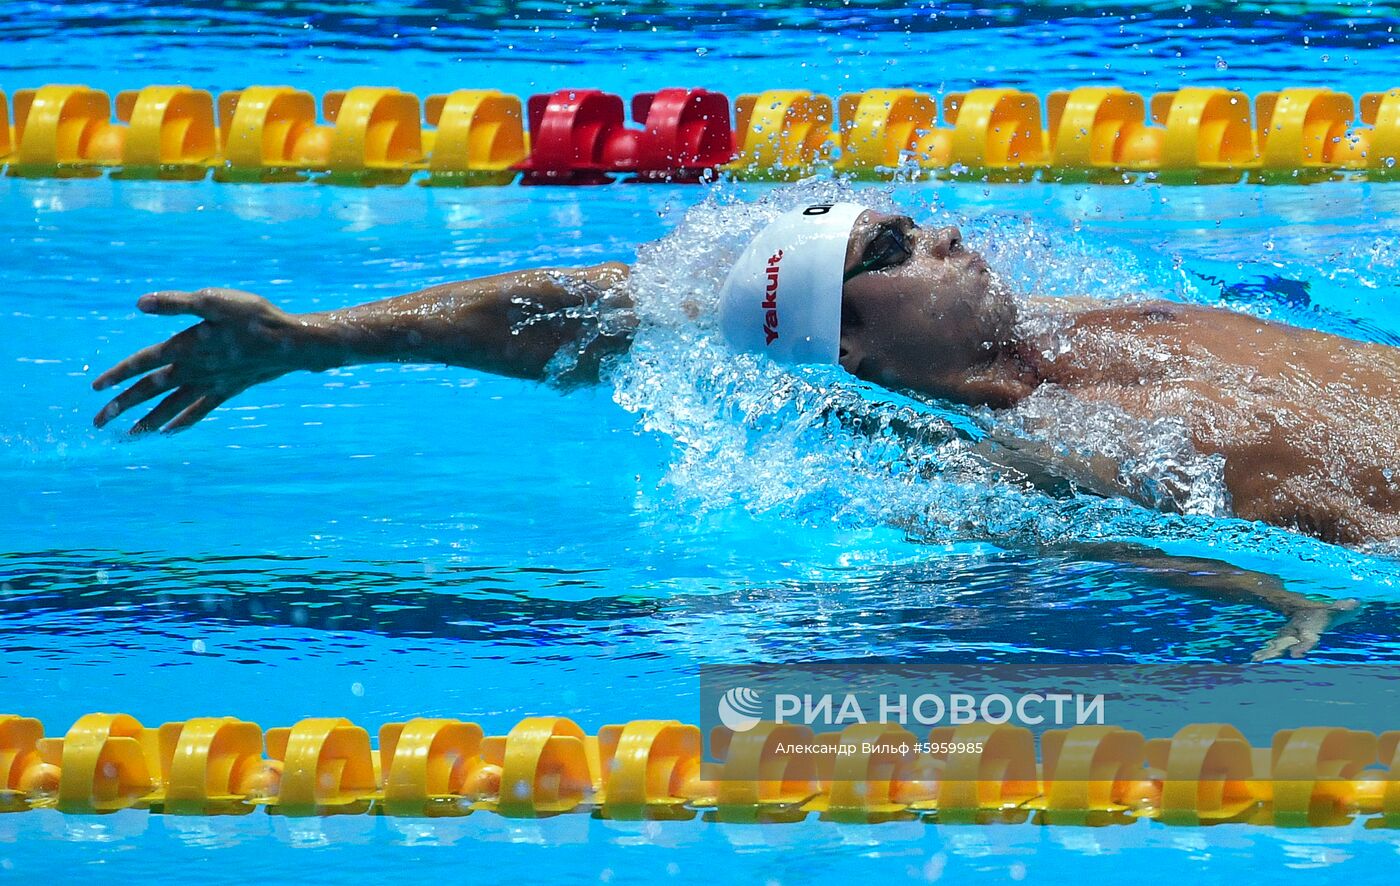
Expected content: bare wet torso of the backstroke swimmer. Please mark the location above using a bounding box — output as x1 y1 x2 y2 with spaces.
1039 302 1400 543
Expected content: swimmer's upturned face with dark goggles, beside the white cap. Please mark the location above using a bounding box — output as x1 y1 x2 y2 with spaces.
841 210 1014 386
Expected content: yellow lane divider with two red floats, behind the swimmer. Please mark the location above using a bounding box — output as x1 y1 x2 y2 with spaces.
0 85 1400 185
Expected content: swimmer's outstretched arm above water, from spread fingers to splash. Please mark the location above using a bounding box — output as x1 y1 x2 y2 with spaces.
92 262 636 434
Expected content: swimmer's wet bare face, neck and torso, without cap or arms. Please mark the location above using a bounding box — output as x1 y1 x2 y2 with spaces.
841 213 1400 544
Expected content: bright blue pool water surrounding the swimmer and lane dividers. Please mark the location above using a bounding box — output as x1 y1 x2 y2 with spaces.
8 3 1400 883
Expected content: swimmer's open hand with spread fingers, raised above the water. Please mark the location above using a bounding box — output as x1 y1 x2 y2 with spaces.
92 288 323 434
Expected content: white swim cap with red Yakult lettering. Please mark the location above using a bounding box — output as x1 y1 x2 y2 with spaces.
720 203 865 364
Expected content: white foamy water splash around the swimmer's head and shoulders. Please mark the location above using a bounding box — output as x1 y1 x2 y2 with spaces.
612 181 1400 595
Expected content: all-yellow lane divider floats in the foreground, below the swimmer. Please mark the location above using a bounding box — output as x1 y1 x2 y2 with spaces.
0 714 1400 827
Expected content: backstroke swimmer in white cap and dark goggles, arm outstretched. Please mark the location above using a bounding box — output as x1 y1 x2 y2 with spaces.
92 203 1400 544
